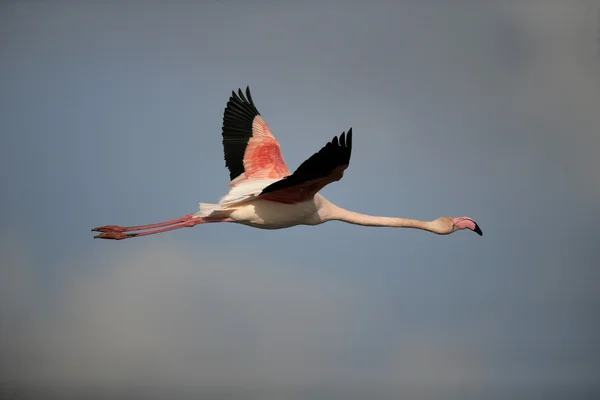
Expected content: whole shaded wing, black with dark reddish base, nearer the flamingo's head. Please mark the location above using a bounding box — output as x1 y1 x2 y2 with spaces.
259 128 352 204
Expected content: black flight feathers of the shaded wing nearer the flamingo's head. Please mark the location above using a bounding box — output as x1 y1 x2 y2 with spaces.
261 128 352 194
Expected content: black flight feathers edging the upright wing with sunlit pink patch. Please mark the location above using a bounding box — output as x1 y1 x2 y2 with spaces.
223 87 260 180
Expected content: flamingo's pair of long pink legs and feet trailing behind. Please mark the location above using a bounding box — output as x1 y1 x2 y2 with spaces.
92 214 233 240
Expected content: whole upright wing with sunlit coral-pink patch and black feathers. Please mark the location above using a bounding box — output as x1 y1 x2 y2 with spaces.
223 87 290 186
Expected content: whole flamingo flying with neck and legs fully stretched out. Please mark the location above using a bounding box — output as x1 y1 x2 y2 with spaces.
92 87 483 240
